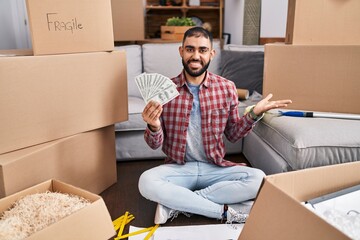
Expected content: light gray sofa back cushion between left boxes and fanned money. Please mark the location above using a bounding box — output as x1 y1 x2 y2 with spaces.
115 45 142 97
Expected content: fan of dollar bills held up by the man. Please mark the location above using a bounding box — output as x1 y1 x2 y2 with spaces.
135 73 179 105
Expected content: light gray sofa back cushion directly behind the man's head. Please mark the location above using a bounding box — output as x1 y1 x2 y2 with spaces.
142 41 221 78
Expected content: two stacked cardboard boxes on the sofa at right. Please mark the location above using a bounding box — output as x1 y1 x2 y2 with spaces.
263 0 360 114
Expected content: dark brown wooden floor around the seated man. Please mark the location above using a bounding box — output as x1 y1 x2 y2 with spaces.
100 154 249 236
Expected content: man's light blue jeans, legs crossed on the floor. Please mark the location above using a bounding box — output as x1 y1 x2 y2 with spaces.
139 162 265 219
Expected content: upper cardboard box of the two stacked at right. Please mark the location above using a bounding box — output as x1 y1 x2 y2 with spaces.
285 0 360 45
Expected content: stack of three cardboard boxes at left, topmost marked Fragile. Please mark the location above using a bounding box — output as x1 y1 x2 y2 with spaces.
0 0 128 198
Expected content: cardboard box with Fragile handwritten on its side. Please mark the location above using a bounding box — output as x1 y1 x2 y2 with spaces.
26 0 114 55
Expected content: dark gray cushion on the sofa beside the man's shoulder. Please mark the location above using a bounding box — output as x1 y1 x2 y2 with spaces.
221 50 264 94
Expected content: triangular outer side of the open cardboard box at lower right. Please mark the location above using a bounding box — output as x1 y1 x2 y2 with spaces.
239 180 349 240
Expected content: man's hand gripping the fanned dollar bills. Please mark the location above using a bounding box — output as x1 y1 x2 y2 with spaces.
142 101 162 132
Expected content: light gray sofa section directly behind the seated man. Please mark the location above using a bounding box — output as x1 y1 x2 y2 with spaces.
115 41 263 161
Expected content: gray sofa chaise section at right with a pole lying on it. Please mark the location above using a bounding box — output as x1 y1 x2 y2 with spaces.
243 114 360 174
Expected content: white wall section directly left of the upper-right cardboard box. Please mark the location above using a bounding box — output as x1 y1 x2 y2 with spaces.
260 0 288 38
